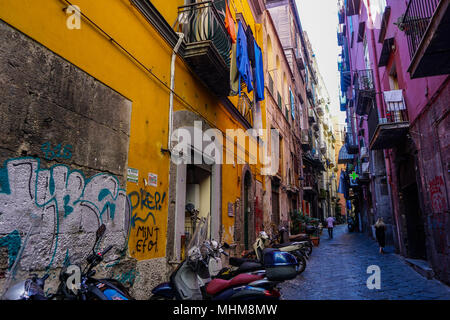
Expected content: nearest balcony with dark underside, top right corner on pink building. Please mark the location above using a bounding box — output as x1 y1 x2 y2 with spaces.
400 0 450 79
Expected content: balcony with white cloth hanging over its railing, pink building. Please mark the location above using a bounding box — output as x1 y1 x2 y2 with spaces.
369 90 409 150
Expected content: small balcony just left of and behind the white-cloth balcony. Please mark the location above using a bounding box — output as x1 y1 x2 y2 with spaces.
353 69 375 116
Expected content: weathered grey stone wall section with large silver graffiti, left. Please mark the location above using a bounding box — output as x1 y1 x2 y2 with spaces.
0 21 136 291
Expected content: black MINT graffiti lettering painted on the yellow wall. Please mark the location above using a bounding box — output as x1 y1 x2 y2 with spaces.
128 188 166 259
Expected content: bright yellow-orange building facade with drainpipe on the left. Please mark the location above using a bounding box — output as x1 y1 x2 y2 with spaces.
0 0 266 298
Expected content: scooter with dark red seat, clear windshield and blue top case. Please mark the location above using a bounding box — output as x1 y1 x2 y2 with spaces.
150 218 297 300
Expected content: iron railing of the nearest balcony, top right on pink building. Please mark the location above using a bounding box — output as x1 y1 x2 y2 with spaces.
402 0 440 58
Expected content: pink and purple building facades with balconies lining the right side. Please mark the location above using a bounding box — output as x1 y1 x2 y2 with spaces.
338 0 450 283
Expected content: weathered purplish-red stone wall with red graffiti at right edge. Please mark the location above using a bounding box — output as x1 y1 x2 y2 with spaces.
410 81 450 283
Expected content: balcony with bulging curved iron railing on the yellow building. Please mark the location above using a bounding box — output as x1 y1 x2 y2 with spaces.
175 1 231 97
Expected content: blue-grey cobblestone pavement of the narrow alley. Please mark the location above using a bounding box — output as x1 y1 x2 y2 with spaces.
281 225 450 300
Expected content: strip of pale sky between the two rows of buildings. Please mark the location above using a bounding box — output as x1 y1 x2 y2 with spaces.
296 0 345 123
